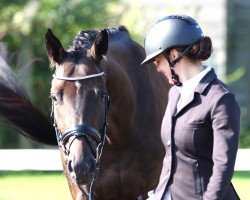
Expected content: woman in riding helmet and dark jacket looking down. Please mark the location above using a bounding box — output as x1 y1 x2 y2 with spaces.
142 15 240 200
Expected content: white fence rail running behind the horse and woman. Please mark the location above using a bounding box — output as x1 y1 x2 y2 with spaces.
0 149 250 171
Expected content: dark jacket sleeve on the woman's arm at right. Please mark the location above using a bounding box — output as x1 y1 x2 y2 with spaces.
203 92 240 200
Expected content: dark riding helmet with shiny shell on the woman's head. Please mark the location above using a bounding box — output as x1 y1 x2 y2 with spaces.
141 15 203 65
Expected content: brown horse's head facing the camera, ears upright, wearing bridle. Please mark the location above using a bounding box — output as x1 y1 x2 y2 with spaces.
45 29 109 198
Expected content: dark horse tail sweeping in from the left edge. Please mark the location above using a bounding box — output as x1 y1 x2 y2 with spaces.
0 56 57 145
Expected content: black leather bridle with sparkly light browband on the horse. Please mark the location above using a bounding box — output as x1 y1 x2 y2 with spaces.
51 72 110 200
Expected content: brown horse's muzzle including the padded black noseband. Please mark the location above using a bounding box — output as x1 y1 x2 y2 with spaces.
58 124 102 184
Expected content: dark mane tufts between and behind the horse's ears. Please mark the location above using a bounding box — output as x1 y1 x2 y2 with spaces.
68 26 131 52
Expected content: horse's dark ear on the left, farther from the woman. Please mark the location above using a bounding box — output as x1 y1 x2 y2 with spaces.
45 28 67 64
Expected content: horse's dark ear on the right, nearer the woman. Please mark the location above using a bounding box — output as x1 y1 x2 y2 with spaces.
91 29 108 62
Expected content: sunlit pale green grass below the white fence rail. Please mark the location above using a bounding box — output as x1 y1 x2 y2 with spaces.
0 171 250 200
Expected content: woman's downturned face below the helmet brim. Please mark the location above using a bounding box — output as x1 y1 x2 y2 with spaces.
154 54 174 84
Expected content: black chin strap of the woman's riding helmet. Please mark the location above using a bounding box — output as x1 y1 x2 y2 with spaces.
163 45 192 87
